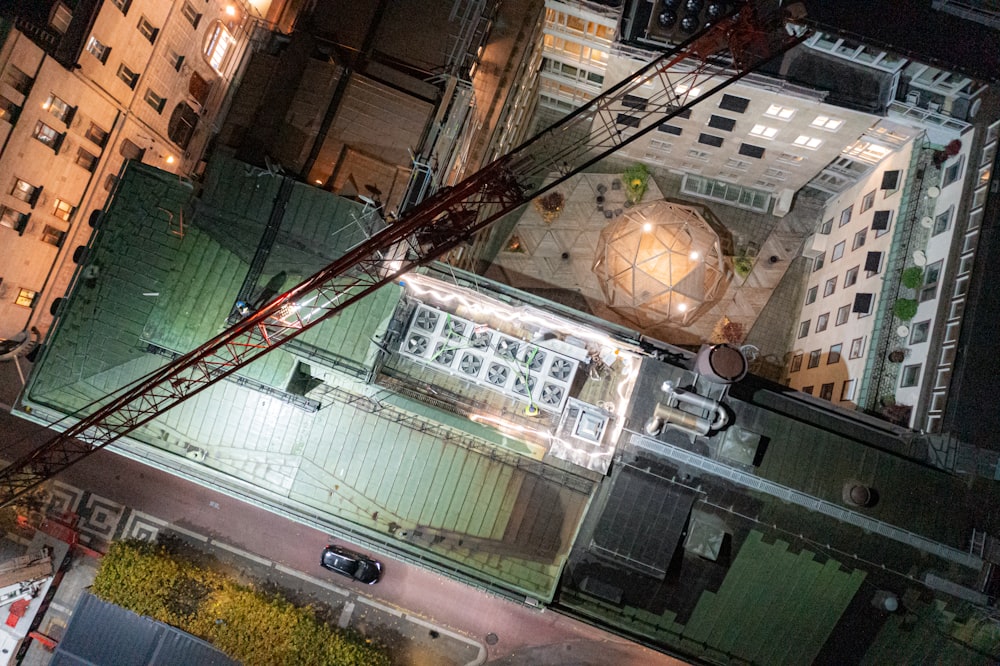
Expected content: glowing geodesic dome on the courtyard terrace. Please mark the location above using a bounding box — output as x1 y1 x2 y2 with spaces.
594 201 728 328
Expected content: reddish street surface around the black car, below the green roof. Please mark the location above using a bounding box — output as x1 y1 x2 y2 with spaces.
0 410 683 666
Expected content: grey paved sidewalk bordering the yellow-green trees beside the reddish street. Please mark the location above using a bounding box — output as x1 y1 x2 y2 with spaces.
10 484 486 666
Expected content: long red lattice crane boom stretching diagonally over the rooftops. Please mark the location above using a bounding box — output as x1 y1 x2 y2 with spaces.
0 4 806 505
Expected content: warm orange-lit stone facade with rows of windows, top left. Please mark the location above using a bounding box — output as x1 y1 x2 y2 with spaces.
0 0 283 339
